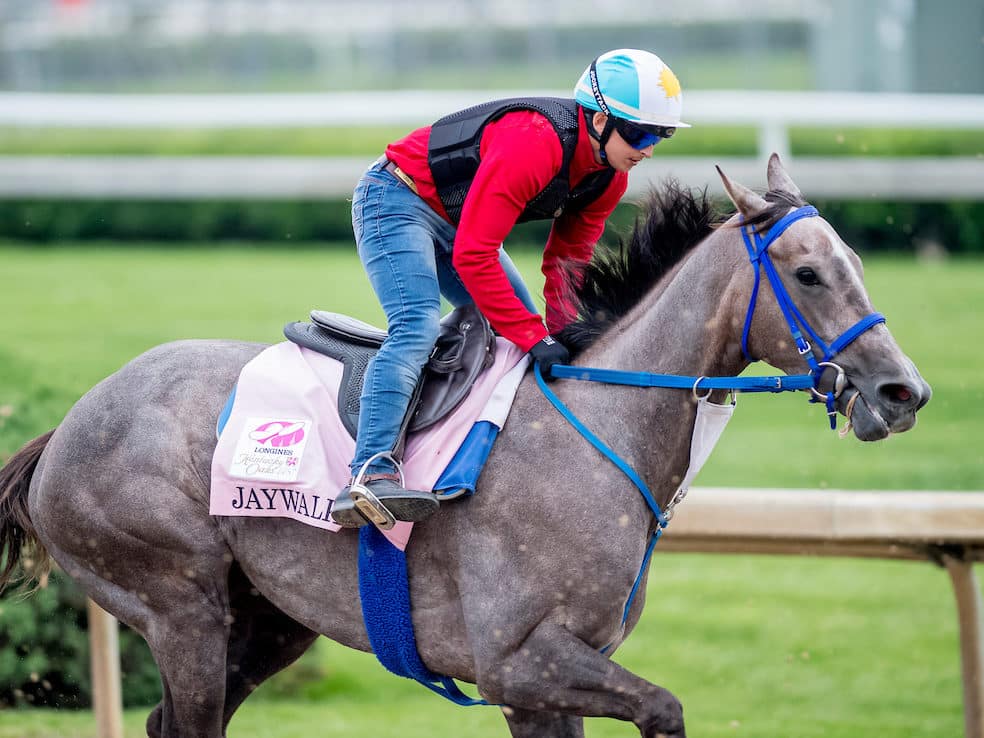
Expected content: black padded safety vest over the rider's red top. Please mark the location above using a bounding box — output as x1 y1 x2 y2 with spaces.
427 97 615 225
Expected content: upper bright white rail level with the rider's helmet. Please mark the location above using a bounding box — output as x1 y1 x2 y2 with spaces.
0 90 984 128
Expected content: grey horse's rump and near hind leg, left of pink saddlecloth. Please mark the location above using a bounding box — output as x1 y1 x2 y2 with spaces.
30 342 268 738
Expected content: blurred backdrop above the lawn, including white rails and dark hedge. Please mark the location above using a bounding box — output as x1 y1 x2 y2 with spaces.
0 0 984 253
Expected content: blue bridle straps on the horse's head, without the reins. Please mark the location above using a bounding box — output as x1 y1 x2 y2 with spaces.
741 205 885 429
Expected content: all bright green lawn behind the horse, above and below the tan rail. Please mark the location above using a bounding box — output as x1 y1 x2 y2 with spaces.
0 244 984 738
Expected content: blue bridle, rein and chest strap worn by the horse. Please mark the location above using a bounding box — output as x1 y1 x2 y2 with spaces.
533 205 885 652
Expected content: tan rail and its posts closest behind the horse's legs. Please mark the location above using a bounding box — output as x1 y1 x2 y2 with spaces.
90 488 984 738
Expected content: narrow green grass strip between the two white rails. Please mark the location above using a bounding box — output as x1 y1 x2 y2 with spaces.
0 126 984 157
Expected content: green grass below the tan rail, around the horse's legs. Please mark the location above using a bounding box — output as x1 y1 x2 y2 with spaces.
0 555 962 738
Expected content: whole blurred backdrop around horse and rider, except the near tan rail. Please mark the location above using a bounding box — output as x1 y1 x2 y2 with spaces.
0 0 984 738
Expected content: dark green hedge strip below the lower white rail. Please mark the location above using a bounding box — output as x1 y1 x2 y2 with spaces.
0 200 984 254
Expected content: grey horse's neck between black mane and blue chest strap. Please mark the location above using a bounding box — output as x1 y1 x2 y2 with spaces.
570 228 750 506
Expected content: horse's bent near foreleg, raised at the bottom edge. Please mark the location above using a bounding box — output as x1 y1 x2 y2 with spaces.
477 623 685 738
